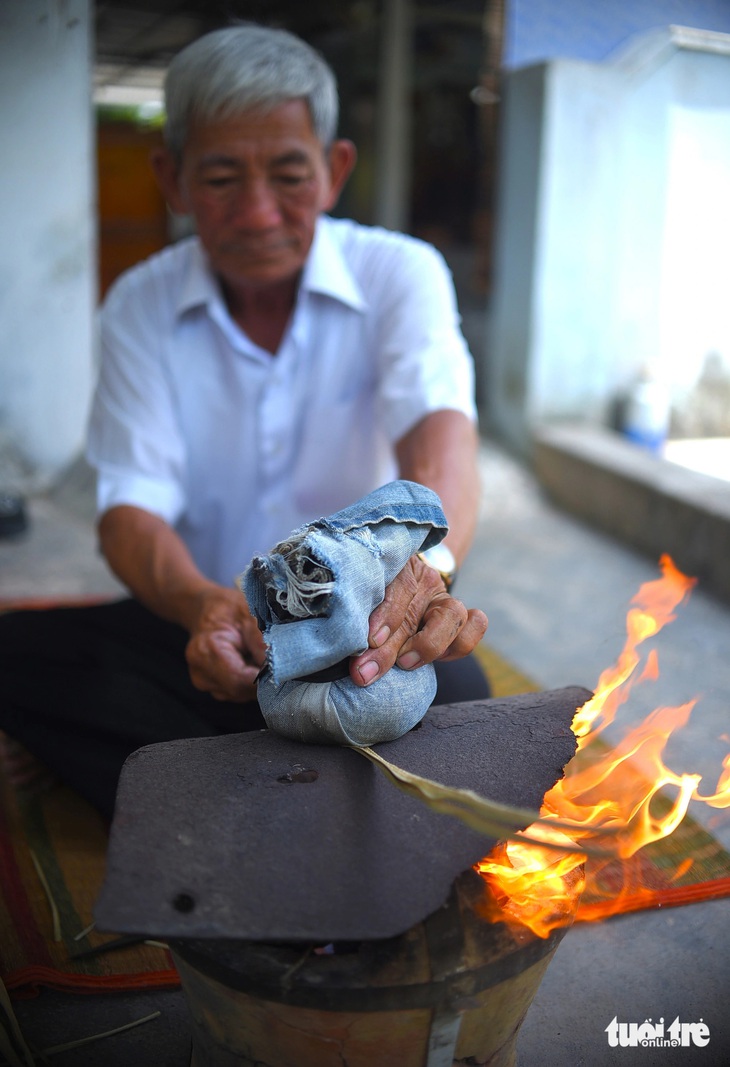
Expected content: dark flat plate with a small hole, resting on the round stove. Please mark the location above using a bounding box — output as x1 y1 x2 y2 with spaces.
95 687 590 942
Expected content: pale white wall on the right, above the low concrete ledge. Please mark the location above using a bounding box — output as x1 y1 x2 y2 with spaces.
482 25 730 451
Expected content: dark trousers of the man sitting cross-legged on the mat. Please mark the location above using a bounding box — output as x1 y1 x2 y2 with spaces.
0 600 489 818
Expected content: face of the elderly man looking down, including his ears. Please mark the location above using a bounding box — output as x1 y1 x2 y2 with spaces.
172 99 354 287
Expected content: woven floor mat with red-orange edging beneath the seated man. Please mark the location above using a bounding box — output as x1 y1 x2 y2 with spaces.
0 602 730 996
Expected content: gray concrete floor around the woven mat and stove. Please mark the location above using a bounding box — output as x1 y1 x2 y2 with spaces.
0 444 730 1067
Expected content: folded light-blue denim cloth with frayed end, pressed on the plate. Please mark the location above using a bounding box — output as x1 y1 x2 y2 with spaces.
240 481 448 745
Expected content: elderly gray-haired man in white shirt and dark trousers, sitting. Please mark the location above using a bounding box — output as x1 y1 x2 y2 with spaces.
0 26 488 813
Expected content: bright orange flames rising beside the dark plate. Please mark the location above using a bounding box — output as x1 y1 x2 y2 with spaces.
476 556 730 937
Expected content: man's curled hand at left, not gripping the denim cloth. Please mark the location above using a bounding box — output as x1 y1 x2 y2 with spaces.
185 586 266 703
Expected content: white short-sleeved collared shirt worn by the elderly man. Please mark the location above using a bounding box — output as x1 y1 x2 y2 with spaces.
88 218 476 585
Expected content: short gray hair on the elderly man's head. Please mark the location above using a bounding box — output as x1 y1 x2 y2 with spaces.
164 23 338 160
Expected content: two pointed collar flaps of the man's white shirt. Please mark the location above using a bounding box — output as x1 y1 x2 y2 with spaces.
169 217 367 316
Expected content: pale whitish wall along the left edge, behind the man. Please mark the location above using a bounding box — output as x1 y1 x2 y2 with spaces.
0 0 96 489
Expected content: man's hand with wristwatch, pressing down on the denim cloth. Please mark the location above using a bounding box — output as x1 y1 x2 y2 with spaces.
350 556 487 686
